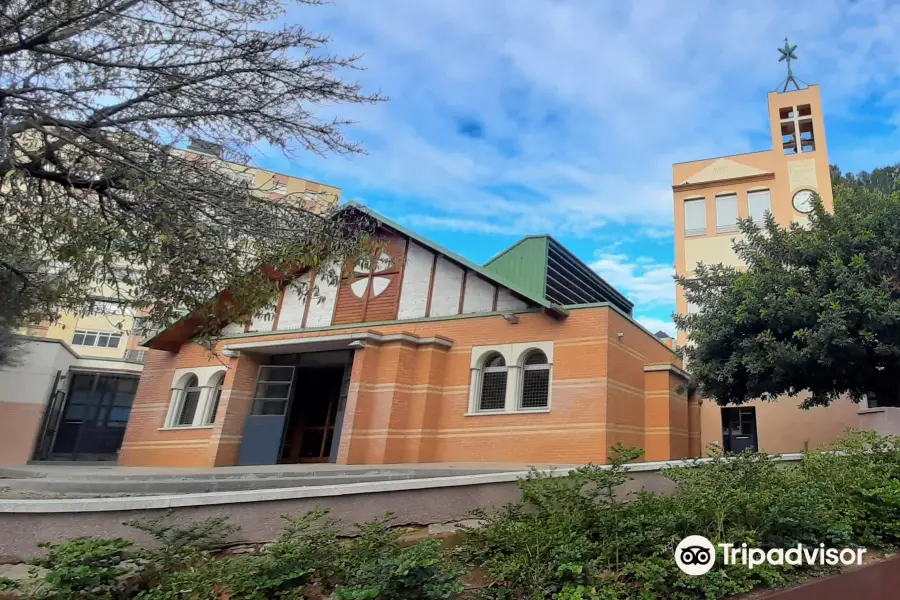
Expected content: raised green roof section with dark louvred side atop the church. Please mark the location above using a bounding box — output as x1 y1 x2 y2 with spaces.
484 235 634 315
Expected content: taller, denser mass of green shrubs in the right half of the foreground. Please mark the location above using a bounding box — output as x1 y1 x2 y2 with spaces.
461 433 900 599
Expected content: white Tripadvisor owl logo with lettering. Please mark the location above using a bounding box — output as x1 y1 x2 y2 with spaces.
675 535 866 575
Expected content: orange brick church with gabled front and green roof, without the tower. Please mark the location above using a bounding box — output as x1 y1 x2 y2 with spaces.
119 203 700 467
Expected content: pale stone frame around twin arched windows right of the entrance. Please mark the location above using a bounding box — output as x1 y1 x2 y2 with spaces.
465 341 553 416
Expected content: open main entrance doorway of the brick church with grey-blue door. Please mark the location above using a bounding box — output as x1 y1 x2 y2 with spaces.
238 350 353 465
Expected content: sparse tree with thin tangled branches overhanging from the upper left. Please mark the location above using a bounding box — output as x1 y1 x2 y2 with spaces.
0 0 382 356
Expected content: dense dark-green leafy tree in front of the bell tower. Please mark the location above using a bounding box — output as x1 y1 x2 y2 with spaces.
676 184 900 407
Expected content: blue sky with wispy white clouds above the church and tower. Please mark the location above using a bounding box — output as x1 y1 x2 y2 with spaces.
250 0 900 332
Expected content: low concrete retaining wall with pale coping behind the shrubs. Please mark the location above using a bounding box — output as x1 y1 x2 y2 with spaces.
0 464 675 563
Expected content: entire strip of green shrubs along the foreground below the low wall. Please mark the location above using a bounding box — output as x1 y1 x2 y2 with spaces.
12 432 900 600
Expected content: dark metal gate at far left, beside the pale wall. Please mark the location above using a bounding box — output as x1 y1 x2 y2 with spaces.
38 373 138 461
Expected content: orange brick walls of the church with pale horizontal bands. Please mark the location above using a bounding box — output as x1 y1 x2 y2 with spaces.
122 307 699 466
